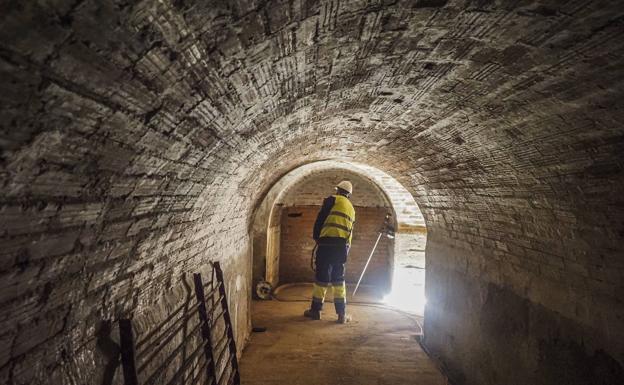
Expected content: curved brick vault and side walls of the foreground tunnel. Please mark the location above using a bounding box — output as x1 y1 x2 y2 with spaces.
0 0 624 384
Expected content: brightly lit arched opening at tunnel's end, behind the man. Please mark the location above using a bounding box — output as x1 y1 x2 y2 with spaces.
252 160 427 315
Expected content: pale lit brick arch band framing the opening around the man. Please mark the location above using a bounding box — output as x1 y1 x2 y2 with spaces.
252 160 426 308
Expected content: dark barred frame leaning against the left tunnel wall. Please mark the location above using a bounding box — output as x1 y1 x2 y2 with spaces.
119 262 240 385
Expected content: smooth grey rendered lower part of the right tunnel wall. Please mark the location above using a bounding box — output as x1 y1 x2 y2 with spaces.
424 246 624 385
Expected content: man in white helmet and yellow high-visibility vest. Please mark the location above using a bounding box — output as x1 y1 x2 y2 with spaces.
303 180 355 323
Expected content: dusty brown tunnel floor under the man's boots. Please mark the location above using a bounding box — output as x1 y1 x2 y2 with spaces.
240 286 447 385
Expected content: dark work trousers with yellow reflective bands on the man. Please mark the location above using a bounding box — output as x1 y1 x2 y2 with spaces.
311 244 349 314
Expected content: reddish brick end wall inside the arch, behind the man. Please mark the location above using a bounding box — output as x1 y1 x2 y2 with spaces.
275 166 394 290
